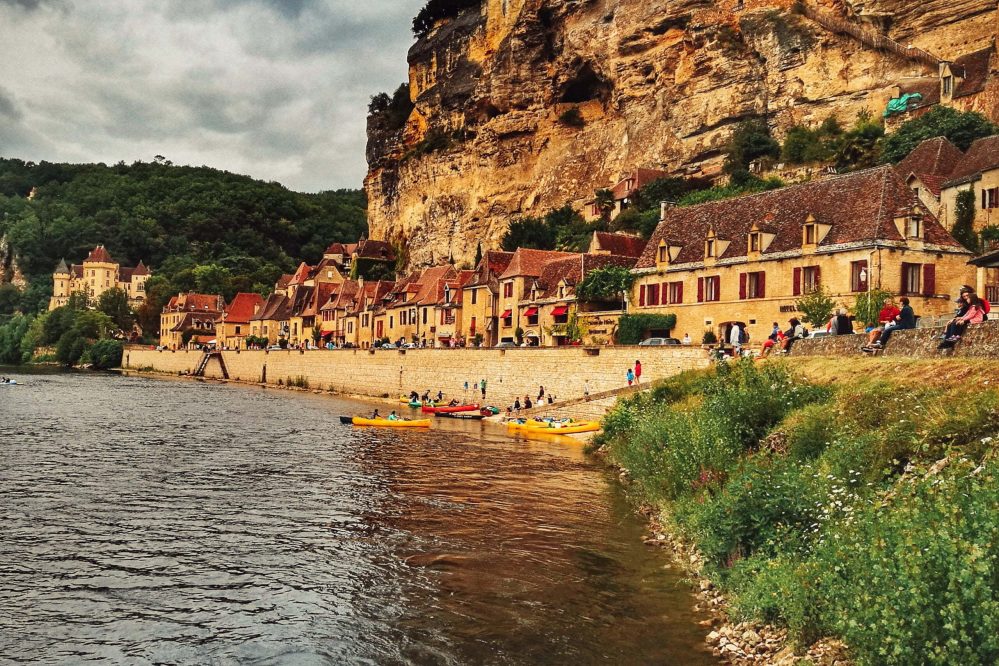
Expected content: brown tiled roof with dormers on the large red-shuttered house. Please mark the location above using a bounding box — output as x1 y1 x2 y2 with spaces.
637 166 961 268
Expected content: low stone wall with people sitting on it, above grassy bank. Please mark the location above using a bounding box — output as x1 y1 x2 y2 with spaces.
791 320 999 359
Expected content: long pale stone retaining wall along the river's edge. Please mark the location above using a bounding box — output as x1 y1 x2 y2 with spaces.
122 347 710 407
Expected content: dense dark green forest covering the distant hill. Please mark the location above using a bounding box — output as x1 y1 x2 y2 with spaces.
0 159 367 314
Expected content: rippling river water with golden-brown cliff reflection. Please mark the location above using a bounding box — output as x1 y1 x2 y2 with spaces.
0 372 713 666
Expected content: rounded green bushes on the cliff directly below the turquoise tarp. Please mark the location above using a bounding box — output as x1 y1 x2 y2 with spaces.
881 105 999 164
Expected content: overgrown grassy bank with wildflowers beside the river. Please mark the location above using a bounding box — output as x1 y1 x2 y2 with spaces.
596 359 999 664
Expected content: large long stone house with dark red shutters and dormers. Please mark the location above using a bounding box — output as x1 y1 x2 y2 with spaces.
631 166 974 341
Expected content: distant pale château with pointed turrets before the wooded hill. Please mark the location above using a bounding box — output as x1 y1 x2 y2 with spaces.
49 245 151 310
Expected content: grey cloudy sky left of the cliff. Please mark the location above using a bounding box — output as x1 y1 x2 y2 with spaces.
0 0 425 191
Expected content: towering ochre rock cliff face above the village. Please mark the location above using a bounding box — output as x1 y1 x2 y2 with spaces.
365 0 997 265
